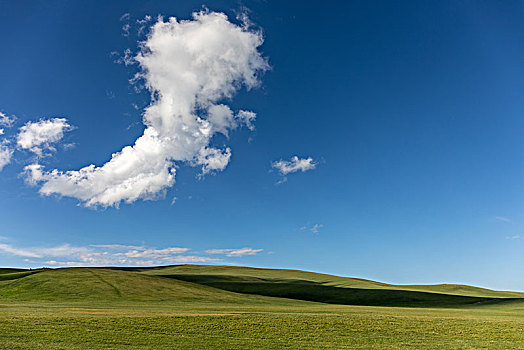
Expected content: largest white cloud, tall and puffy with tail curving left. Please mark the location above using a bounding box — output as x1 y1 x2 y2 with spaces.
25 11 268 206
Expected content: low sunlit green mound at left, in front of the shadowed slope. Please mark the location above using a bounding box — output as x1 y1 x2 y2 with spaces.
0 268 264 302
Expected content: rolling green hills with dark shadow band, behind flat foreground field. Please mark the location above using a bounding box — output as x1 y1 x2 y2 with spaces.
0 265 524 307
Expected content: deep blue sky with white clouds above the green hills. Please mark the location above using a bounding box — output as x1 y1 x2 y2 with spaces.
0 1 524 290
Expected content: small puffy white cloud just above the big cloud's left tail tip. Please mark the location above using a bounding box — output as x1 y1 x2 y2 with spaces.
16 118 71 156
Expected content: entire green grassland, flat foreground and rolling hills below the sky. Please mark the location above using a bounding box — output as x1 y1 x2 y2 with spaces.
0 265 524 349
